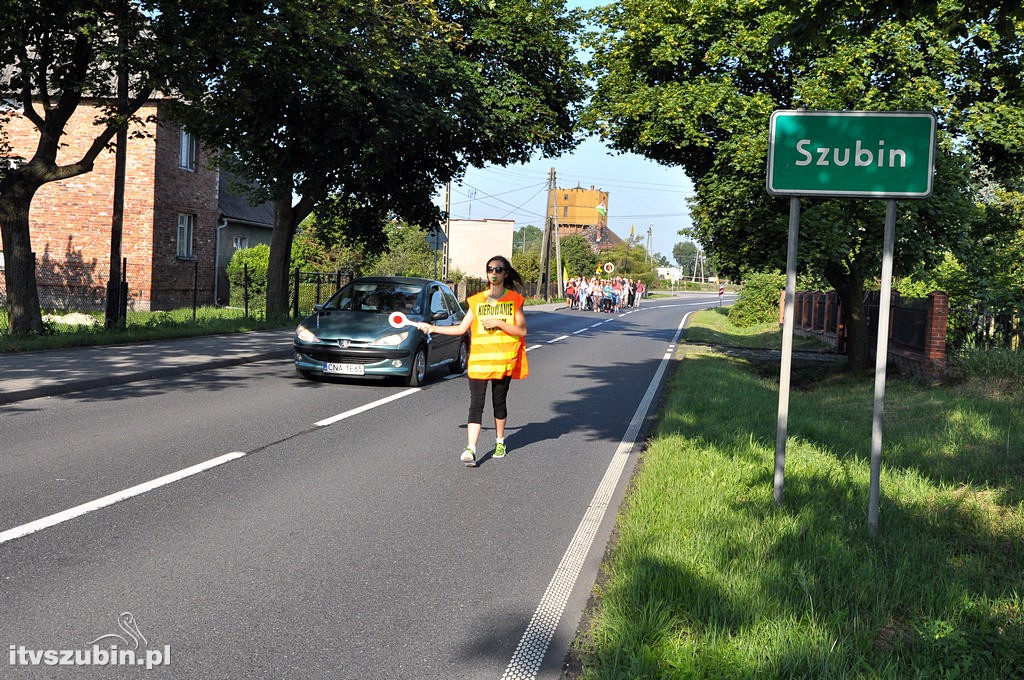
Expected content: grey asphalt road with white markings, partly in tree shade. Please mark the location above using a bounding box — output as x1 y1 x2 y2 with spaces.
0 295 733 680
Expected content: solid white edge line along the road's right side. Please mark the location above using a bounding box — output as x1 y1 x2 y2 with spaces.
502 312 693 680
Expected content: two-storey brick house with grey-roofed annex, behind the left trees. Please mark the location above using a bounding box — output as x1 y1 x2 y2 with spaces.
1 99 272 310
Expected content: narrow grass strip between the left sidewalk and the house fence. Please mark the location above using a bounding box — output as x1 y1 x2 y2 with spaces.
0 307 292 352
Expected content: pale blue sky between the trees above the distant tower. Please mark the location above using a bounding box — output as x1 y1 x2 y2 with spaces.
440 0 693 263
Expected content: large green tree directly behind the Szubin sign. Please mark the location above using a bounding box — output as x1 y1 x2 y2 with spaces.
586 0 1024 366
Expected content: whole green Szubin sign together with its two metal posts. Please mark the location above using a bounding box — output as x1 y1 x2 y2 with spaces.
767 111 936 535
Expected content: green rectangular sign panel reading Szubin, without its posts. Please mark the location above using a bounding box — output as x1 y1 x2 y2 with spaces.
768 111 935 199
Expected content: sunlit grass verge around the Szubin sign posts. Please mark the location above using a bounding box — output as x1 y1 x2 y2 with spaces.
574 311 1024 679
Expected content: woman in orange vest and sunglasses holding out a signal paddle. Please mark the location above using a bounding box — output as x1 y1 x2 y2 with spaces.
416 255 529 467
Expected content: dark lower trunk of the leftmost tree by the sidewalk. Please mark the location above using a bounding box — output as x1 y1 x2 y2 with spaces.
0 177 43 335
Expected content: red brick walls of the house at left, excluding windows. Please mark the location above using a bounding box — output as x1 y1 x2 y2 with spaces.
8 98 218 309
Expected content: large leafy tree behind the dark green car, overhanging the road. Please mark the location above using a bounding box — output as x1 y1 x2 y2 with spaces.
173 0 587 315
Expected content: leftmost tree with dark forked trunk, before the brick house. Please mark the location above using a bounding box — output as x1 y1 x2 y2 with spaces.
0 0 218 334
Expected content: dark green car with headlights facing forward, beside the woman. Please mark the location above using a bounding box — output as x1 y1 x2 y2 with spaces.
294 277 469 386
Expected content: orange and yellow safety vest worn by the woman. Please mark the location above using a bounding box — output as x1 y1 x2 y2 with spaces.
468 291 529 380
